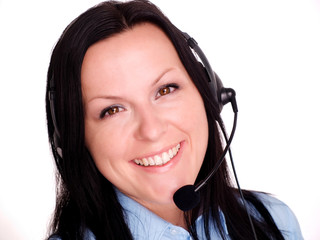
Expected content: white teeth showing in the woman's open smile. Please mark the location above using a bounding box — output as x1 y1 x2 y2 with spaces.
134 143 180 167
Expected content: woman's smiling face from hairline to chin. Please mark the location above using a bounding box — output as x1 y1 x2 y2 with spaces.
81 23 208 208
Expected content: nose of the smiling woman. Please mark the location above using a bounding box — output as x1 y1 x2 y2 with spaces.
135 106 167 141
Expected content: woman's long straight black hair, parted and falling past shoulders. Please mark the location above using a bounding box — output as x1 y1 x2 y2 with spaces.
46 0 283 240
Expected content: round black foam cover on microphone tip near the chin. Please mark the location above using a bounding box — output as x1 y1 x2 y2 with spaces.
173 185 200 211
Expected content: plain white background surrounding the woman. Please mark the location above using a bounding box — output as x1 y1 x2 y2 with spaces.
0 0 320 240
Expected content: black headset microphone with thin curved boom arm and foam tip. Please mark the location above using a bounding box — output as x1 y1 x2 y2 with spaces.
173 88 238 211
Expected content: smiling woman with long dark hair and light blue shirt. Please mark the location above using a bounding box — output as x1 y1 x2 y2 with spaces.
46 0 302 240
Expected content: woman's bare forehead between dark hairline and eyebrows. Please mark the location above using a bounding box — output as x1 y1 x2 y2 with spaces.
81 23 183 99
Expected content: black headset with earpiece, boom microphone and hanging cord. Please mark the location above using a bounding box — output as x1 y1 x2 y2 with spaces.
48 32 257 239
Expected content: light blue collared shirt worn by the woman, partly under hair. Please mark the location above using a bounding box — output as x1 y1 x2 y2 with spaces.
50 190 303 240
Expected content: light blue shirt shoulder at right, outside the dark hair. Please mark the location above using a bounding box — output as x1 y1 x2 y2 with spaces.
255 193 303 239
